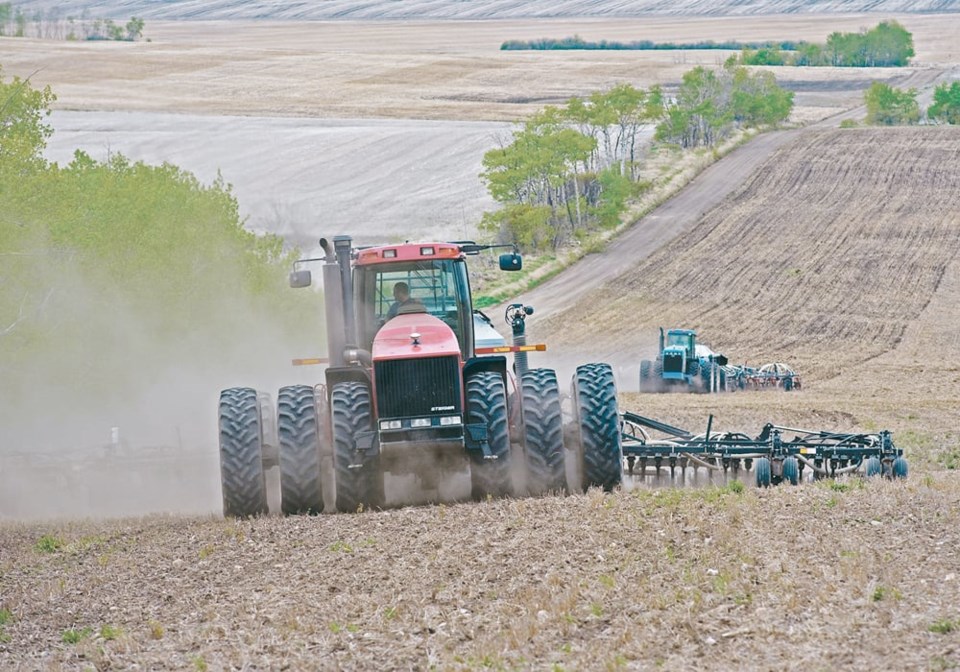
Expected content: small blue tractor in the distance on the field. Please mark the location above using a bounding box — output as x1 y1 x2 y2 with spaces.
640 327 727 392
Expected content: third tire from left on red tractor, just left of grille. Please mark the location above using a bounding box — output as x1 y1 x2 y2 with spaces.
330 382 383 513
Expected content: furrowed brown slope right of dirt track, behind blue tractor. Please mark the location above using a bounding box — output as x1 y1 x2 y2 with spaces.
537 128 960 380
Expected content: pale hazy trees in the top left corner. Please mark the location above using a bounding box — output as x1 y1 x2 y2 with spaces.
0 2 145 42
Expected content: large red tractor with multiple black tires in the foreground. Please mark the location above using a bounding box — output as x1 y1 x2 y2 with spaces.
220 236 622 516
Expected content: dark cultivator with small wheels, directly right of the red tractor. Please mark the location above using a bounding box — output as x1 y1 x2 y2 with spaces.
620 412 908 487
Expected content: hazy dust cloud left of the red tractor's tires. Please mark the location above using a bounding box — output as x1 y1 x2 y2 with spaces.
0 269 325 520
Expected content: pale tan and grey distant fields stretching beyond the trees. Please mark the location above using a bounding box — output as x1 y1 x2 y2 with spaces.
9 12 960 244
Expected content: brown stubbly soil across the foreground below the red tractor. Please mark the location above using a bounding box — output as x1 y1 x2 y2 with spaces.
0 474 960 670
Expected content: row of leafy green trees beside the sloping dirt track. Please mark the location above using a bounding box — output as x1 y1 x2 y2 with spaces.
480 66 793 251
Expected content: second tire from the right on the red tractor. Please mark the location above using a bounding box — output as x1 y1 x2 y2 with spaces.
520 369 567 495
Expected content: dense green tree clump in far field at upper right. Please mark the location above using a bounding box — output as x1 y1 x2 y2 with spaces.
737 21 914 68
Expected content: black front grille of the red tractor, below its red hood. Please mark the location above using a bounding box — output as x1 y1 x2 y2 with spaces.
373 356 462 418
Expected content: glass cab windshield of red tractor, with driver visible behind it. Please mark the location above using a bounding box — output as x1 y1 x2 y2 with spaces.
354 259 473 358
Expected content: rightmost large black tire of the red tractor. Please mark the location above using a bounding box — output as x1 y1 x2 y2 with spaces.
573 364 623 492
